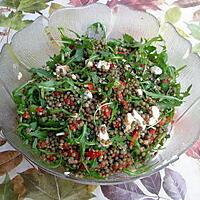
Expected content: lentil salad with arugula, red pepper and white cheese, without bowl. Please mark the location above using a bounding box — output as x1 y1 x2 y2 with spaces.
13 23 191 178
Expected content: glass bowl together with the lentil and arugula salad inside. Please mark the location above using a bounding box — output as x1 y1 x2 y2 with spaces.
0 4 200 184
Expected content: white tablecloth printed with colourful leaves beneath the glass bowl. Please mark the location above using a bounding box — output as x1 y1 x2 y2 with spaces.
0 0 200 200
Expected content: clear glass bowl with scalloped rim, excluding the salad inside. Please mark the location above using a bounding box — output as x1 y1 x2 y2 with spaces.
0 4 200 185
